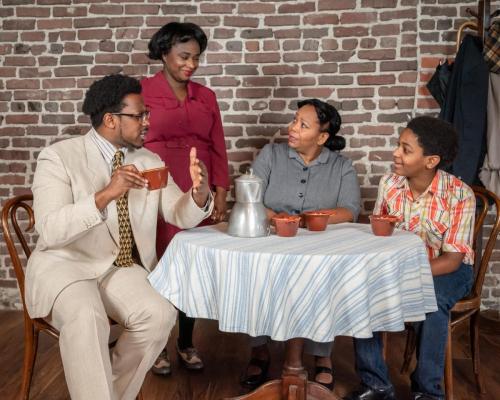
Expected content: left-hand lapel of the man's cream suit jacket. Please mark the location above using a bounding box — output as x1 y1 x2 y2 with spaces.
85 132 120 245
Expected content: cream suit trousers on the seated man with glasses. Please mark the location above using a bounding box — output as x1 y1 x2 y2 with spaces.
47 264 177 400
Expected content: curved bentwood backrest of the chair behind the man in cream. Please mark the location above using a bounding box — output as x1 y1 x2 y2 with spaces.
2 194 35 309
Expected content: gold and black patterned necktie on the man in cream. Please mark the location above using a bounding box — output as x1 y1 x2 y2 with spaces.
113 150 134 267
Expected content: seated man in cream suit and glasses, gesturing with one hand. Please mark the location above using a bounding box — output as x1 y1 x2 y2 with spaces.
26 75 212 400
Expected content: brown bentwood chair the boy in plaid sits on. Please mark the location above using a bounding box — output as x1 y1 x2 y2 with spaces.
401 186 500 400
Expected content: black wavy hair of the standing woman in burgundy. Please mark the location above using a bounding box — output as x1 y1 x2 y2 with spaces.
148 22 208 60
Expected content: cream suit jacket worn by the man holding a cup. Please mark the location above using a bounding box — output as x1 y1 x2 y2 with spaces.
25 133 213 318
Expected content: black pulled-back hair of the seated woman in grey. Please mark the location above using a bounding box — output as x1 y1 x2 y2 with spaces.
297 99 345 151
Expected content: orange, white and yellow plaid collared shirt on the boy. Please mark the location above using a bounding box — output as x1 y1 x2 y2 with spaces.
373 170 476 265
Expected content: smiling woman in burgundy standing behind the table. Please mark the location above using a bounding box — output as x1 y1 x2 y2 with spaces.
141 22 229 375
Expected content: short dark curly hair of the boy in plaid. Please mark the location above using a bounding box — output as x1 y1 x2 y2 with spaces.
406 115 458 168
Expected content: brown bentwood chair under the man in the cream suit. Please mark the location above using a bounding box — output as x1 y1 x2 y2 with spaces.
2 194 143 400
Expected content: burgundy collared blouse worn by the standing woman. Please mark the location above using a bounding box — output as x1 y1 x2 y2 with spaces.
141 71 229 191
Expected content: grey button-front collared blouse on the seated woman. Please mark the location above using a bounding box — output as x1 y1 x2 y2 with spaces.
252 143 360 220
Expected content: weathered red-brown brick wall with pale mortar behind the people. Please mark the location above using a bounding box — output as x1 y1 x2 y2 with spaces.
0 0 500 308
